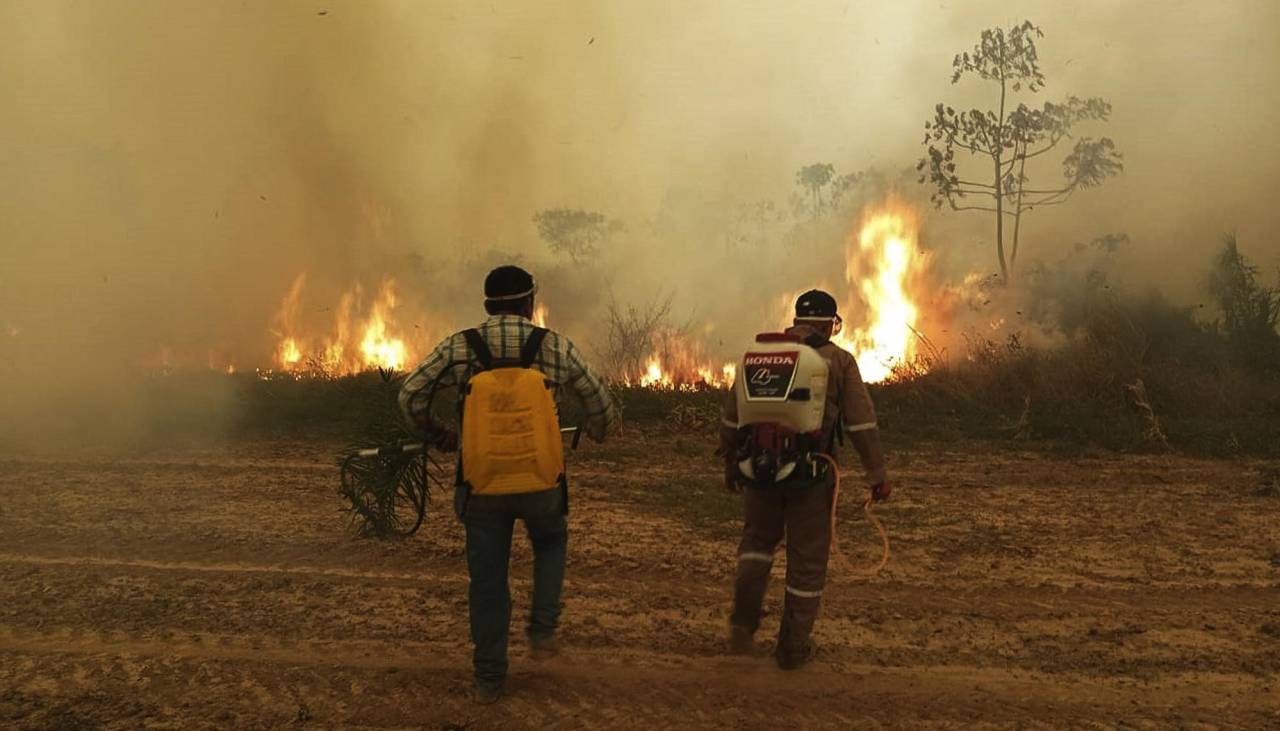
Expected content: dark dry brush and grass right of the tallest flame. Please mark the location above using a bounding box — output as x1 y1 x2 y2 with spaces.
873 294 1280 457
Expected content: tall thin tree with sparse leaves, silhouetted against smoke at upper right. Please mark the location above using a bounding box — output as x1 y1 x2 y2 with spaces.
916 20 1124 283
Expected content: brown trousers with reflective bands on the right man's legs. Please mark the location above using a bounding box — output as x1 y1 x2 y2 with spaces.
730 481 832 655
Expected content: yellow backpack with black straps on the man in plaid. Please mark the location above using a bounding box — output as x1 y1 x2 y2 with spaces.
458 328 564 495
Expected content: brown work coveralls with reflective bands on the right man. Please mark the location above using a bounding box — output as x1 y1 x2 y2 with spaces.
721 325 884 657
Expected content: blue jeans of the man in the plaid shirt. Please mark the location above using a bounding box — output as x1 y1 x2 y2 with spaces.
456 488 568 686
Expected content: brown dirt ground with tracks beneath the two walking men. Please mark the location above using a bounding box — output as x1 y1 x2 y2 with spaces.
0 433 1280 730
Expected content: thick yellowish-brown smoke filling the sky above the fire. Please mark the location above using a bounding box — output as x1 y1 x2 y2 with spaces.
0 0 1280 440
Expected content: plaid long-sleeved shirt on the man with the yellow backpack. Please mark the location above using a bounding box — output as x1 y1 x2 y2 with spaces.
399 314 618 440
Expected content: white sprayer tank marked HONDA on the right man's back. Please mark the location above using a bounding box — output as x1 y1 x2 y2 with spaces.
735 333 829 434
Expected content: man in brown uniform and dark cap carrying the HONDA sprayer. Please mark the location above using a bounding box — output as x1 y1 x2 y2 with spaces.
721 289 890 670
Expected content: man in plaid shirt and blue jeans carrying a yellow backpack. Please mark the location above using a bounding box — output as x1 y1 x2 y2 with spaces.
399 266 618 703
